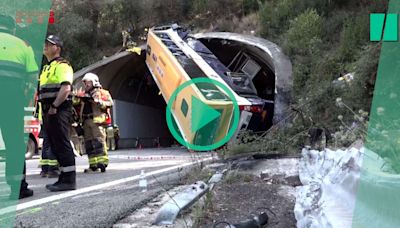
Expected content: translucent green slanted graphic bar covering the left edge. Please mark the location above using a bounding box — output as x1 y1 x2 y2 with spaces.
0 0 51 227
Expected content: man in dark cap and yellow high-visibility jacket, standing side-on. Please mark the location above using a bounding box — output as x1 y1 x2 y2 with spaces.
39 35 76 192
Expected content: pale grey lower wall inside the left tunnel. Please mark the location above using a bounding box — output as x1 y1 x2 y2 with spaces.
113 100 171 148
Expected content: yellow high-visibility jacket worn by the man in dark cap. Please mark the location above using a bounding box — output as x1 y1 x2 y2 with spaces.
39 57 74 104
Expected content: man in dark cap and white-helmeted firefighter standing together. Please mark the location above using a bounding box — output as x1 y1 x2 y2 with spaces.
38 35 113 192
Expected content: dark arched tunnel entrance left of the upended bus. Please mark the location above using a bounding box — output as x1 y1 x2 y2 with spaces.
74 51 174 148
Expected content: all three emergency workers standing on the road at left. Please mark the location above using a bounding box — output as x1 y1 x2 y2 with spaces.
0 15 117 199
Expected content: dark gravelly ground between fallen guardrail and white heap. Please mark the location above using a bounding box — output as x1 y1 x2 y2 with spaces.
196 158 300 228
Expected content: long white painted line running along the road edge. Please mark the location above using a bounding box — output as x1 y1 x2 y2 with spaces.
0 157 213 215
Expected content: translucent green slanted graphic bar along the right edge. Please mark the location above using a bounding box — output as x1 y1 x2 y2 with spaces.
352 0 400 228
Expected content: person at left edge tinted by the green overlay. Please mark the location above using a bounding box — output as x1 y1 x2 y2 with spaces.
0 15 38 199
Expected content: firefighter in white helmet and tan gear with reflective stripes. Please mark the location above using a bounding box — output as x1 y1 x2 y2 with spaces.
76 73 113 173
